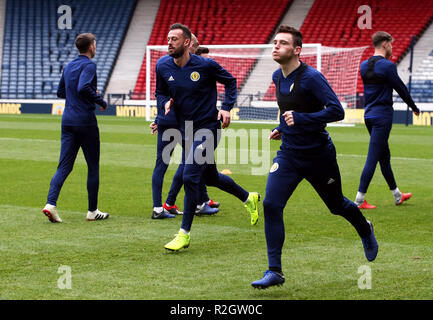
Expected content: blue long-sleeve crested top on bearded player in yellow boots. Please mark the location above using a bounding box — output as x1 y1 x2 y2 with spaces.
155 54 237 130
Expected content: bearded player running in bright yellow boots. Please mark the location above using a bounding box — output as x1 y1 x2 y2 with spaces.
156 23 259 251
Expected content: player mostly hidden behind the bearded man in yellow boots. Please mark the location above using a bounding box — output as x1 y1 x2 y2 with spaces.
149 34 220 219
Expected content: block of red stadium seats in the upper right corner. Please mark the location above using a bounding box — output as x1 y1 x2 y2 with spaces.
265 0 433 100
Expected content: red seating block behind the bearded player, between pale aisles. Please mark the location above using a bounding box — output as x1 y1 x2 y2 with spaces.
132 0 291 99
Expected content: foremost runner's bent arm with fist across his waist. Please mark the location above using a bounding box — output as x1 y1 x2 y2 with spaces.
284 72 344 126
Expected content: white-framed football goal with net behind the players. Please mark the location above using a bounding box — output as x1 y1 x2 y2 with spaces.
142 44 367 123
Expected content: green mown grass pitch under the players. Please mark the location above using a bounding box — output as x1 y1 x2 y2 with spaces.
0 115 433 300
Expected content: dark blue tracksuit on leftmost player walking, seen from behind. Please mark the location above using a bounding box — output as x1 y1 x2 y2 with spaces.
47 55 107 211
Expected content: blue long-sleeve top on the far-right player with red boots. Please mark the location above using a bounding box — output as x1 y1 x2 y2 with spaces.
361 56 418 119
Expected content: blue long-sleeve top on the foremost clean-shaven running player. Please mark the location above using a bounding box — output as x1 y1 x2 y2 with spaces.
272 66 344 151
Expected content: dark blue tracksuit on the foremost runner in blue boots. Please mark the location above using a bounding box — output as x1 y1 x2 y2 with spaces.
263 63 370 271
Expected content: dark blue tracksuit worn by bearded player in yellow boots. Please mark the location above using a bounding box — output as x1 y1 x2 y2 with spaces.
155 54 248 230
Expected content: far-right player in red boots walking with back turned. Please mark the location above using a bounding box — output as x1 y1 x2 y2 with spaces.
355 31 419 209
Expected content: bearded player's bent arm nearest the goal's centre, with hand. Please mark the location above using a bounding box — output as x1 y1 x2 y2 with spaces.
209 59 237 128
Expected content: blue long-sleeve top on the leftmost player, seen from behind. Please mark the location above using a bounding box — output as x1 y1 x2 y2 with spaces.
57 55 107 126
